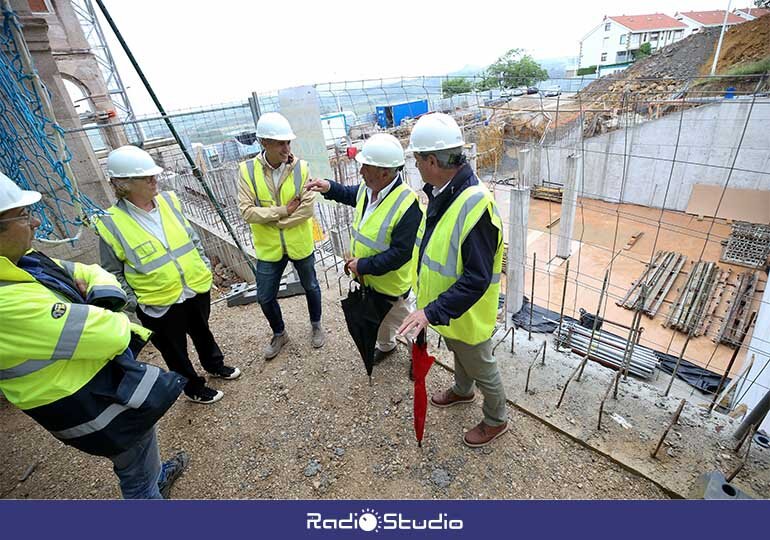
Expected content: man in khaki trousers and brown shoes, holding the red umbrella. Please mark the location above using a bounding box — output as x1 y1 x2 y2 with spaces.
399 113 508 447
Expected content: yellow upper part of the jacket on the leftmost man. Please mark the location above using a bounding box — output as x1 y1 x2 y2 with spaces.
0 257 150 410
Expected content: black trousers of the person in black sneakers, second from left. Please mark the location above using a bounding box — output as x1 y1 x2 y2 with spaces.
136 292 224 394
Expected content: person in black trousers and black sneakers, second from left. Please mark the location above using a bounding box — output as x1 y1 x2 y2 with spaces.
96 145 241 404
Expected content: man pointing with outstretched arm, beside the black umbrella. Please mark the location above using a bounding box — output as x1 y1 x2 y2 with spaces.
306 133 422 364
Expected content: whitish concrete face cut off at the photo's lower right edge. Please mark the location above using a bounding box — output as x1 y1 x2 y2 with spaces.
733 285 770 433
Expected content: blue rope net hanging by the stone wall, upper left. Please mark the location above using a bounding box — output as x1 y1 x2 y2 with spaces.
0 5 103 242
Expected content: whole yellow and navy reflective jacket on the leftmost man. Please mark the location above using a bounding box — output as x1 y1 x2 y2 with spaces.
0 252 186 456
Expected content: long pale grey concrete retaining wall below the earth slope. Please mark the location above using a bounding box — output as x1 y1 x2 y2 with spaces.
540 98 770 210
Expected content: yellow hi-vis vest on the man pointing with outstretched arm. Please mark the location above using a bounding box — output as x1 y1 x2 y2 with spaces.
350 183 417 296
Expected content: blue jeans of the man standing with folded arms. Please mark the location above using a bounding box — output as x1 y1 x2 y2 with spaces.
257 253 321 334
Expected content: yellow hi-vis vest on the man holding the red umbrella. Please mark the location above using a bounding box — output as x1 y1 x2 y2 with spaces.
415 184 503 345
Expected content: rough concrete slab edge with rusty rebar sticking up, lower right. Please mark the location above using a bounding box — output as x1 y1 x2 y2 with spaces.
432 331 770 498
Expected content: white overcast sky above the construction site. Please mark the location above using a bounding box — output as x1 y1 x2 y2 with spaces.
97 0 732 114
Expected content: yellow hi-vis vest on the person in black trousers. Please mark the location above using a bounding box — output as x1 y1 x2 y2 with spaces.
96 191 212 306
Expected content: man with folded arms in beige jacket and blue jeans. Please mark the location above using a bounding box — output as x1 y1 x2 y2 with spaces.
238 112 326 360
